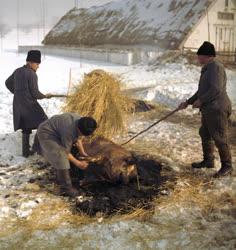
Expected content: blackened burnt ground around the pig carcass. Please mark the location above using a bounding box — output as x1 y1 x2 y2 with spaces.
71 155 174 216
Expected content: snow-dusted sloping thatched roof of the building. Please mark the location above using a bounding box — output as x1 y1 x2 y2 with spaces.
44 0 214 49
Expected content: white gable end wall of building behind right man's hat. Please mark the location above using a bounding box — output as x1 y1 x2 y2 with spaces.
184 0 236 52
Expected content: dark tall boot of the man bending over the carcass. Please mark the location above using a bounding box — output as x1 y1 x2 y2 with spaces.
57 169 80 198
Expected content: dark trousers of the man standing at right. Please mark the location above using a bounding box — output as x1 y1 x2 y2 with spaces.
199 110 232 163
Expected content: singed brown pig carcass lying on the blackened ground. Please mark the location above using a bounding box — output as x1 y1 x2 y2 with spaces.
72 137 137 186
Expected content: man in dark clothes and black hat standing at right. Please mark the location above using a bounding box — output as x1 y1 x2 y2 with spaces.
179 42 233 177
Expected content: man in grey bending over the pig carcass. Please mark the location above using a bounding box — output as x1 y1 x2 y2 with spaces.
34 113 97 197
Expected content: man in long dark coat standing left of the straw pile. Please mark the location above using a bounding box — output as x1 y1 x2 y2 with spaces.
6 50 51 157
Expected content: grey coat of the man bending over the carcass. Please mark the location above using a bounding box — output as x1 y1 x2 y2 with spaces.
33 113 81 169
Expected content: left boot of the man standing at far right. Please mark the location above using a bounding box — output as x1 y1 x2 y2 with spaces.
192 141 215 168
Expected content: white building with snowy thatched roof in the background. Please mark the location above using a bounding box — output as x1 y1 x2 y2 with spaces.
17 0 236 65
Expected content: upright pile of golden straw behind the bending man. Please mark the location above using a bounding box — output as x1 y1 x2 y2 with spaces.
64 70 133 138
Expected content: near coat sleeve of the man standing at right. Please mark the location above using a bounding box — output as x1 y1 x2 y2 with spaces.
198 64 225 104
